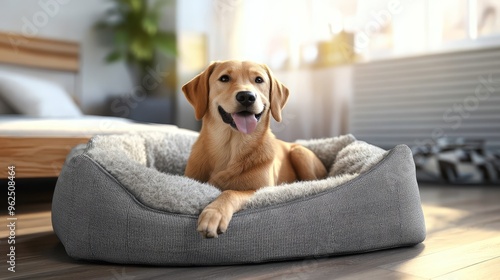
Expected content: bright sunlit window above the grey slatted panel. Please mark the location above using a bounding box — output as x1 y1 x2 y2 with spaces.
226 0 500 66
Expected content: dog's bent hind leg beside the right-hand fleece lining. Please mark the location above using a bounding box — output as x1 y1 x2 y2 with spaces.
290 144 327 181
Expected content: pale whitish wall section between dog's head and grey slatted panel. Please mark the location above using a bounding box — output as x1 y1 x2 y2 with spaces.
272 65 352 141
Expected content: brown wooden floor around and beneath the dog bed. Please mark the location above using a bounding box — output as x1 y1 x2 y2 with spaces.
0 186 500 280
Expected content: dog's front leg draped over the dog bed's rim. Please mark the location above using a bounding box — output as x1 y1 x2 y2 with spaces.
197 190 255 238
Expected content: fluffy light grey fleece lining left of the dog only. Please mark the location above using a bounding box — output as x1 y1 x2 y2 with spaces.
84 129 220 214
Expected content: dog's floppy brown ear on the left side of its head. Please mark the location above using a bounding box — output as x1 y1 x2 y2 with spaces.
182 62 217 120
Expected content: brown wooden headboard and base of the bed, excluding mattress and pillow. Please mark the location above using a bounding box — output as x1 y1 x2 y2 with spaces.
0 32 83 179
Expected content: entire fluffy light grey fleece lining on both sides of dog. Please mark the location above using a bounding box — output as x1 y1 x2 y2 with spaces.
85 129 386 214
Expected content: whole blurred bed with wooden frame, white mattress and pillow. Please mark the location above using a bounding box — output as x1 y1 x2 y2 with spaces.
0 33 178 178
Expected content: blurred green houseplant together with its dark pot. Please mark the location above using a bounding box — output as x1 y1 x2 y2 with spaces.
96 0 177 123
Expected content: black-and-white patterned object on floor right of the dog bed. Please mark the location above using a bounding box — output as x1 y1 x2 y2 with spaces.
412 138 500 184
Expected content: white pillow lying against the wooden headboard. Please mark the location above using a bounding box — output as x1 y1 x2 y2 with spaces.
0 71 82 117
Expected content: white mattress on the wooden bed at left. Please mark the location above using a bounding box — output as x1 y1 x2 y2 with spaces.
0 115 177 137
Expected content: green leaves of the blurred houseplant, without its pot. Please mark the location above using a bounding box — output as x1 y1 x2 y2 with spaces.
96 0 177 93
